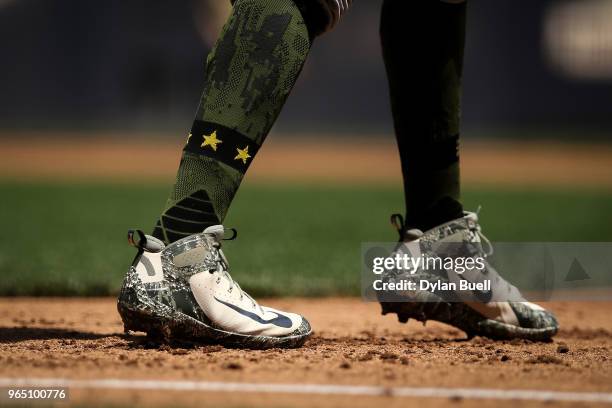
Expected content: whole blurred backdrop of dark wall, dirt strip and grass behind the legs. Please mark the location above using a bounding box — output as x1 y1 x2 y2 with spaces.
0 0 612 296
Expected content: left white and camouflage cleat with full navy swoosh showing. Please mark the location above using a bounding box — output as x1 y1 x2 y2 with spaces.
117 225 312 349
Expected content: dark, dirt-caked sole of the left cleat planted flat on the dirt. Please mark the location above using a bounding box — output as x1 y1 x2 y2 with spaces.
117 301 312 349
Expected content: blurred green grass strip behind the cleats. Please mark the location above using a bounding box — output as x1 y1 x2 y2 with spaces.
0 183 612 296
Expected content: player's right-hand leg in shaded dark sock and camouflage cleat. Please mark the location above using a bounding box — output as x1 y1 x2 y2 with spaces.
381 0 558 340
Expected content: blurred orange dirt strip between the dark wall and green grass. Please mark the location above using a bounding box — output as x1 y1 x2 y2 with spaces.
0 133 612 189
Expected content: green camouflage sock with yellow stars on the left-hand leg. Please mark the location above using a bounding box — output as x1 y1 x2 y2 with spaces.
153 0 311 243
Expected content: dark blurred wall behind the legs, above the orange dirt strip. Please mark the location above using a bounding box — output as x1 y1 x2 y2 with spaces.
0 0 612 135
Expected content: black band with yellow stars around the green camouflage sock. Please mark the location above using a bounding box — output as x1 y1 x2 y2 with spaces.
183 120 259 173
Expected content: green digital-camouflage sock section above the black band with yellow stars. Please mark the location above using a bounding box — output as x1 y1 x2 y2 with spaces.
196 0 310 144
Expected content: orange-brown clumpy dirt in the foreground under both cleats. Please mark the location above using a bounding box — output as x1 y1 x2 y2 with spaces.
0 298 612 407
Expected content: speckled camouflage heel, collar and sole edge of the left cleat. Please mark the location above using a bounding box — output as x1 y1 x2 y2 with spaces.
117 230 312 349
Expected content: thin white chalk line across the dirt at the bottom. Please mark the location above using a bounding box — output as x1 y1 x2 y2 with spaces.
0 378 612 403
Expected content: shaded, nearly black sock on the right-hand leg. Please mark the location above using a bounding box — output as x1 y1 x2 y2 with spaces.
380 0 466 229
